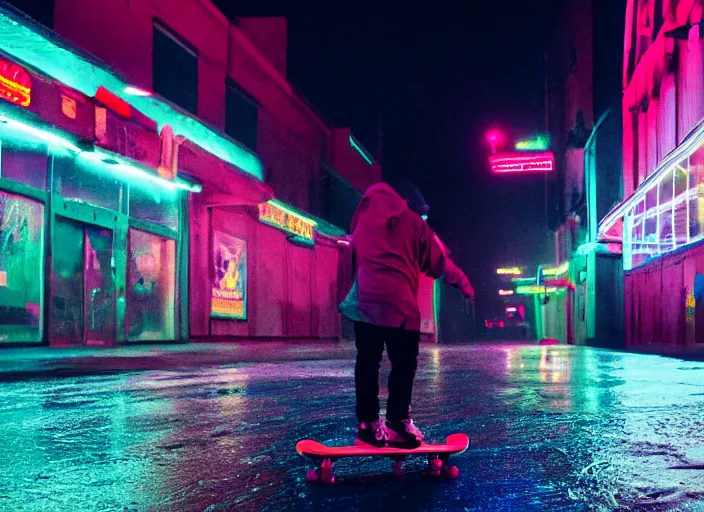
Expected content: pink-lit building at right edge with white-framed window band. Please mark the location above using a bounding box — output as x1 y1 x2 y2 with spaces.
599 0 704 346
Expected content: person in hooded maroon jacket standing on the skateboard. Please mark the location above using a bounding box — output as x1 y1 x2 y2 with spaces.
340 183 474 447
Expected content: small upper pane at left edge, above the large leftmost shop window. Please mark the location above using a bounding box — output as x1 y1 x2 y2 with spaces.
0 139 49 190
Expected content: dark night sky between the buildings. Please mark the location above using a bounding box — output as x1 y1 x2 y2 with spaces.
214 0 556 318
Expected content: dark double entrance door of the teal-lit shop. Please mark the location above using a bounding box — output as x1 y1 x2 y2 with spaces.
50 217 116 345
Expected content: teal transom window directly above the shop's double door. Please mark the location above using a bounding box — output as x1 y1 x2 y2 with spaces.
54 157 122 211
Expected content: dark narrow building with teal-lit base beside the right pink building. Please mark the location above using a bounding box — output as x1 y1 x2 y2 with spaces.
536 0 625 346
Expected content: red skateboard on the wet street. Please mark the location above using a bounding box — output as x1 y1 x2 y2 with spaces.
296 434 469 484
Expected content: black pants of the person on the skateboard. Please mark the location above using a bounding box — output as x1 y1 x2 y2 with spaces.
354 322 420 422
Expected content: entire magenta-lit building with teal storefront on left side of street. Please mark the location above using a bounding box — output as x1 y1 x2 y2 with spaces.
0 0 390 345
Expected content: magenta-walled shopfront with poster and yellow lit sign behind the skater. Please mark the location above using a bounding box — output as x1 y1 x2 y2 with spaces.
187 146 344 340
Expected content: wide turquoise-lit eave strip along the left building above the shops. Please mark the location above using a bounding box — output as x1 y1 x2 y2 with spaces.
0 8 264 180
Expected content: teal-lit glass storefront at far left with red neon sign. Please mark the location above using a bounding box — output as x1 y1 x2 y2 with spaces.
0 57 197 346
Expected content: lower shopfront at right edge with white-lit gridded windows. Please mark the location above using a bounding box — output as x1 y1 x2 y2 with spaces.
599 118 704 345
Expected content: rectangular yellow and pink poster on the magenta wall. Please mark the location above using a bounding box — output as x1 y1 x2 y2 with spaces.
210 231 247 320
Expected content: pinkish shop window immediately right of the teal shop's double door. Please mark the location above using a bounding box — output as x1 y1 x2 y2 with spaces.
127 229 176 341
